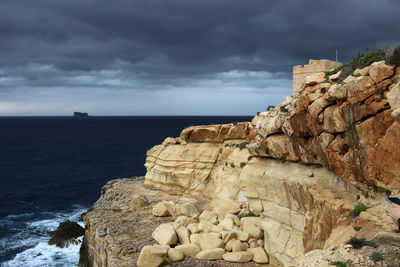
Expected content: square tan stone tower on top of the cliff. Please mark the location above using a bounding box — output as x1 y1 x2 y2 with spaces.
293 59 342 95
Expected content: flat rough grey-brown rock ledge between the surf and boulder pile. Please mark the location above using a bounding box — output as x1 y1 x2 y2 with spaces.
78 179 282 267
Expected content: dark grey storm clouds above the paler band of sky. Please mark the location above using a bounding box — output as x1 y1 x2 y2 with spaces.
0 0 400 115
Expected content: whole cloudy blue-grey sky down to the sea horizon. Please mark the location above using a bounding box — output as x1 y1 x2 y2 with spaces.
0 0 400 116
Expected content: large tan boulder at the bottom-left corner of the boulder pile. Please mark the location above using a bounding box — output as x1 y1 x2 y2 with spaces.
137 245 170 267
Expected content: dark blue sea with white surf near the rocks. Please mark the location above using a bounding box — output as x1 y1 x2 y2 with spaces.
0 116 252 267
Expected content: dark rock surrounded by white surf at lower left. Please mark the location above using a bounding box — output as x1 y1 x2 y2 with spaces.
48 220 85 248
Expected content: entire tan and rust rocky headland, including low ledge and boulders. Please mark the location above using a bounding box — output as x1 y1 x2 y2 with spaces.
80 61 400 266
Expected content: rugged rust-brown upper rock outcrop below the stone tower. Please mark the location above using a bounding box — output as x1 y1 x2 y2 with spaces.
249 61 400 193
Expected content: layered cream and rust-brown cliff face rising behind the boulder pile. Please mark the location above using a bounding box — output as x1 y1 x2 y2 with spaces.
145 62 400 266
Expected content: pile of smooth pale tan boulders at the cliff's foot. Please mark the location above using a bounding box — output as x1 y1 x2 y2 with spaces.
138 201 269 267
